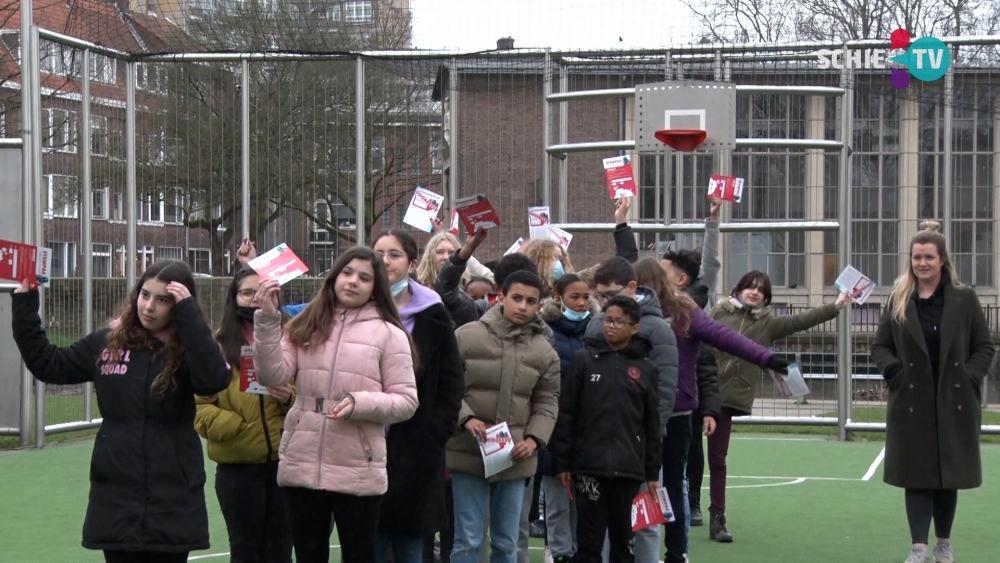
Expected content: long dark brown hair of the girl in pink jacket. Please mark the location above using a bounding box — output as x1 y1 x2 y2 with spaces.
285 246 417 369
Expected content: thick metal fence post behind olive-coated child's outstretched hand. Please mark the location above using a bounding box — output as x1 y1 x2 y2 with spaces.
837 58 854 441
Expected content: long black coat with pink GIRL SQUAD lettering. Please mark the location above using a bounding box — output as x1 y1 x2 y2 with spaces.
13 291 232 552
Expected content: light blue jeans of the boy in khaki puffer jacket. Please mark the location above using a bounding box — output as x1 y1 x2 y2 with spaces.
451 472 525 563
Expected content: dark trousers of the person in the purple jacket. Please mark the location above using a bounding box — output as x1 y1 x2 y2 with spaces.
663 414 691 563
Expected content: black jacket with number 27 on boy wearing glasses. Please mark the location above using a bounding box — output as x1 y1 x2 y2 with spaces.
549 338 662 481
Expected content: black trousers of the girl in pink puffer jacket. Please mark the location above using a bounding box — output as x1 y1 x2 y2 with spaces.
284 487 382 563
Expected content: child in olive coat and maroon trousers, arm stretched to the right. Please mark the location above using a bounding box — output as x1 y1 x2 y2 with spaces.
708 270 851 543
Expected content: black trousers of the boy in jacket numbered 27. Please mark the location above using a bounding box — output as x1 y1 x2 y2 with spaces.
573 475 642 563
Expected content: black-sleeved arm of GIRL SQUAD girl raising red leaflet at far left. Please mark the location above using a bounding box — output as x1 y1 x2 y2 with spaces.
11 285 107 385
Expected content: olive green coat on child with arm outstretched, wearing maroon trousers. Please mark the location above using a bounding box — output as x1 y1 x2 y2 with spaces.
712 298 840 415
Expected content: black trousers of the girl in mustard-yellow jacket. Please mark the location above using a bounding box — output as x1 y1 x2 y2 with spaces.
215 461 292 563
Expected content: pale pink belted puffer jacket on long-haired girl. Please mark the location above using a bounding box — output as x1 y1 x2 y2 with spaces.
253 303 417 496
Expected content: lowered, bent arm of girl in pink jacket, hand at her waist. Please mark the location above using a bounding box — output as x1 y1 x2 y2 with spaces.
350 324 418 424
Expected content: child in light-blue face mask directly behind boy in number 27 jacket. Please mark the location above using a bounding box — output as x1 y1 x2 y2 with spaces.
538 274 600 563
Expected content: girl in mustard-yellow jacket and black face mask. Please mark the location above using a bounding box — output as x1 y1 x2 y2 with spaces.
194 268 295 563
